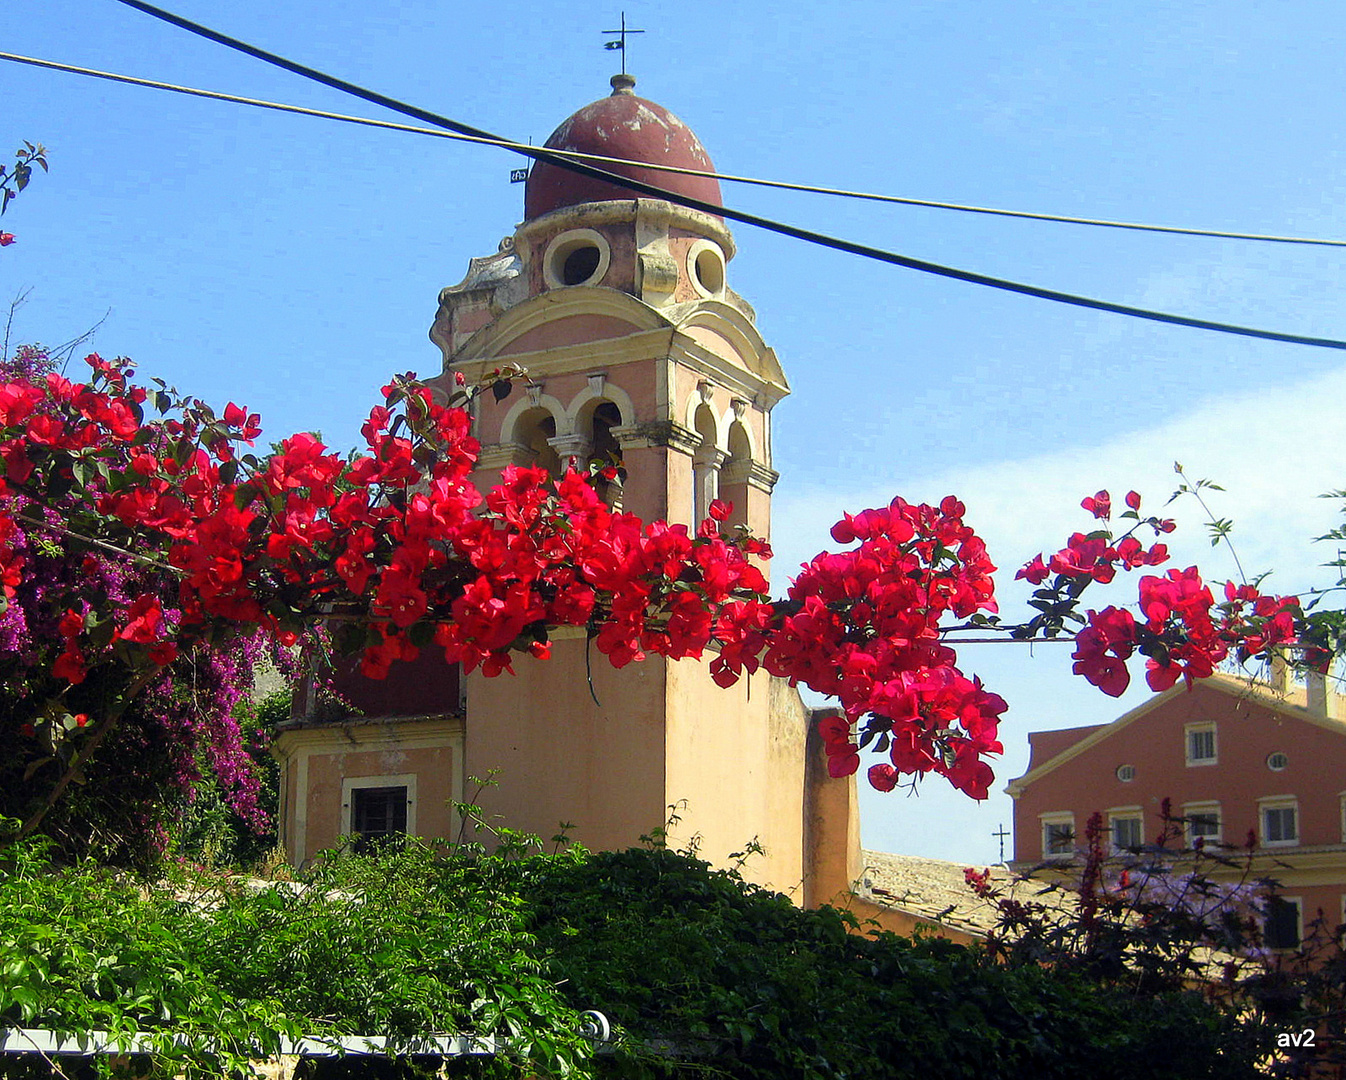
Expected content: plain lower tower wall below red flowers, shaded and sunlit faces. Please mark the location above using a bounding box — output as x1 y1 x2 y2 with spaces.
466 638 804 896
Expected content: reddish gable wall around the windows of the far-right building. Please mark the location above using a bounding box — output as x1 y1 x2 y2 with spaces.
1015 683 1346 860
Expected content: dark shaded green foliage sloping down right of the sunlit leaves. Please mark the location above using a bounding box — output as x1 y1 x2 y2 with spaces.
524 847 1257 1080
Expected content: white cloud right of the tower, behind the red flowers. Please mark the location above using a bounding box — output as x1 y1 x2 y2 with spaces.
773 358 1346 863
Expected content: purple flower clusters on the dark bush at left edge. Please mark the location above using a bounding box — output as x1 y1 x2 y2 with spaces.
0 346 269 860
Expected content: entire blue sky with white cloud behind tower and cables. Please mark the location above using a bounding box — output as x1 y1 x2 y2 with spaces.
0 0 1346 862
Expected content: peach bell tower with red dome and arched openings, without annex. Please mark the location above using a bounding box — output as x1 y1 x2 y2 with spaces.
431 74 808 890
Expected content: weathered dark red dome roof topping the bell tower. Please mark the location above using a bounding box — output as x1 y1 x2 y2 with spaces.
524 75 723 221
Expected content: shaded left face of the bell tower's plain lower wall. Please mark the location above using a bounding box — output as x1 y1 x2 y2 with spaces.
466 638 665 848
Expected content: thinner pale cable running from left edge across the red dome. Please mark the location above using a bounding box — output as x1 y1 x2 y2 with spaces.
0 53 1346 248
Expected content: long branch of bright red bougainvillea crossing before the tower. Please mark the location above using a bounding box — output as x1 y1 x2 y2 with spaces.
0 356 1324 830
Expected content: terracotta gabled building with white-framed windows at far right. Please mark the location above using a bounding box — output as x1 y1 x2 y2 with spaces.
1008 673 1346 948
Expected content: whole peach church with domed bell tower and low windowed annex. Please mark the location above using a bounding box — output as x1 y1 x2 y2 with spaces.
267 75 909 913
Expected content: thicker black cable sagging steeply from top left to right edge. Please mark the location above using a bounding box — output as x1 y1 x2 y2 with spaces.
60 0 1346 350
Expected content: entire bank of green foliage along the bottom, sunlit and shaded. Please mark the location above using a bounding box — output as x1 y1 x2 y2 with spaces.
0 835 1276 1080
